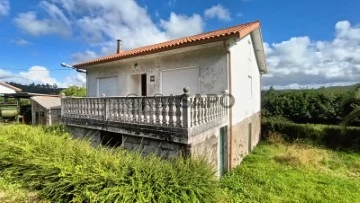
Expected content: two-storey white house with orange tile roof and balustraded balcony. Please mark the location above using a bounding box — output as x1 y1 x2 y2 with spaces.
62 21 267 175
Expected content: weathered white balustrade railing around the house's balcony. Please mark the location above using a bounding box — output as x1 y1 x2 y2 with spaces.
61 90 228 128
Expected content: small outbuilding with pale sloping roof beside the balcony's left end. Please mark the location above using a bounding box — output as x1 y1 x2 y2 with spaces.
30 96 61 126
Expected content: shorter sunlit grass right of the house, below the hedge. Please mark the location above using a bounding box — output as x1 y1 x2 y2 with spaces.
221 135 360 203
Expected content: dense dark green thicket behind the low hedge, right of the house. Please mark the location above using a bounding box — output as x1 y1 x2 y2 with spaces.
262 84 360 126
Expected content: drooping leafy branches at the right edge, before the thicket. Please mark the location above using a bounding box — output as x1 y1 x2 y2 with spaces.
341 84 360 128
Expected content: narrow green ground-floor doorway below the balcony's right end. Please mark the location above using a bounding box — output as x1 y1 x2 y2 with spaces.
219 126 229 176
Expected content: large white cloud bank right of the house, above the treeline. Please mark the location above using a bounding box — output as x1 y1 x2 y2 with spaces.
264 21 360 88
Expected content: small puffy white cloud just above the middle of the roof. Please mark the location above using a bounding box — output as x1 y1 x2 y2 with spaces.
160 12 204 38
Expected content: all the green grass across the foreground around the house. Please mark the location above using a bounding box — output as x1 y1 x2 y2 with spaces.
0 125 360 203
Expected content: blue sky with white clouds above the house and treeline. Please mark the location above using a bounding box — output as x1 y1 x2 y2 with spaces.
0 0 360 88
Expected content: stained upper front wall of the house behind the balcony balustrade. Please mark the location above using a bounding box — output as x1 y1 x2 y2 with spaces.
87 43 227 97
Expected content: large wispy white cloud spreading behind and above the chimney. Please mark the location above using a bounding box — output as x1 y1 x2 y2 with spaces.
14 0 203 55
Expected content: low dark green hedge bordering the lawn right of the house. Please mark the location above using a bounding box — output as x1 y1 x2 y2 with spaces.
262 119 360 151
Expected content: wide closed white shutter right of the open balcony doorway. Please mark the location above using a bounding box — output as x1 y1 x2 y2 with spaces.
161 68 200 96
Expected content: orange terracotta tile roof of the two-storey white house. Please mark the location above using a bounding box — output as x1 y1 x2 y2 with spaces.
74 21 260 67
